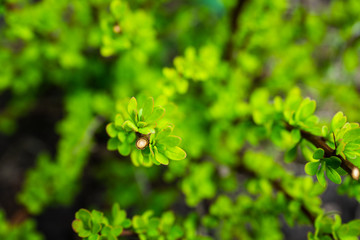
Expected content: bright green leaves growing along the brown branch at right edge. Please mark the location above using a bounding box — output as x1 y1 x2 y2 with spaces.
253 89 360 187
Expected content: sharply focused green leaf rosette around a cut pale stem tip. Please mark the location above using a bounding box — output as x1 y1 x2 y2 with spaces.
106 97 186 167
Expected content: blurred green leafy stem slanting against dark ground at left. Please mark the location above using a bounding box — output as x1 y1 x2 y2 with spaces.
18 93 100 214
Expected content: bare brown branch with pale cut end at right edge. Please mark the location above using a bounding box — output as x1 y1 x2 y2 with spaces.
286 123 360 181
